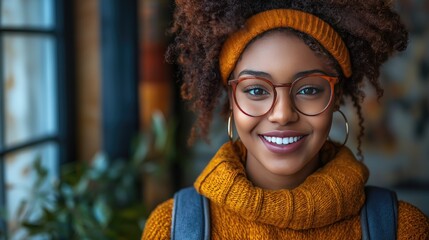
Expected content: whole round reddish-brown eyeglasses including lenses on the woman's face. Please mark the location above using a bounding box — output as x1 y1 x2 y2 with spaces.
228 74 338 117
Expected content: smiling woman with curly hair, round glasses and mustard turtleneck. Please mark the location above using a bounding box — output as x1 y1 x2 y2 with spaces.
142 0 429 239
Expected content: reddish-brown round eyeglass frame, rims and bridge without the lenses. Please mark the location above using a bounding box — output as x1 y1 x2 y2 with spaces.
228 73 339 117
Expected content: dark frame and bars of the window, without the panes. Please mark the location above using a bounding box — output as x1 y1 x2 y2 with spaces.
0 0 76 235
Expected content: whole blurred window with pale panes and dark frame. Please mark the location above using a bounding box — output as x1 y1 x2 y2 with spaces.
0 0 73 236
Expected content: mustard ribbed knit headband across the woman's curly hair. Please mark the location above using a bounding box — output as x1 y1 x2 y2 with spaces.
219 9 352 84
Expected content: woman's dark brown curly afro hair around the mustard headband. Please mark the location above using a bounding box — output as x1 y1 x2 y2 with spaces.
166 0 408 158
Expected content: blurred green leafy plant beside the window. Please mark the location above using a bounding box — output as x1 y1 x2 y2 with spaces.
6 113 176 239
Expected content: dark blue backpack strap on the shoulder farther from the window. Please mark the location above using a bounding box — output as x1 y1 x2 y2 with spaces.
360 186 398 240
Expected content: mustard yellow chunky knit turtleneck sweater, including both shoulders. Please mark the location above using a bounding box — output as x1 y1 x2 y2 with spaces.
142 142 429 240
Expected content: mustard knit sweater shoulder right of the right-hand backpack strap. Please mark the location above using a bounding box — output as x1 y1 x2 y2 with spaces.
397 201 429 240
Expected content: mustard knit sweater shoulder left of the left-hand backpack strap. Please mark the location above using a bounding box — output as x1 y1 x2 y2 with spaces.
141 199 173 240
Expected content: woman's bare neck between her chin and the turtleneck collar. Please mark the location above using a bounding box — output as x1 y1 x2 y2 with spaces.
246 155 321 190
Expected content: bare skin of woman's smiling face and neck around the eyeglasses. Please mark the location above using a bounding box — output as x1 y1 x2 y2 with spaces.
229 31 333 189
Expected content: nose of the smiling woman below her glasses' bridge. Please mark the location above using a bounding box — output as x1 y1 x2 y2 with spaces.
268 91 299 125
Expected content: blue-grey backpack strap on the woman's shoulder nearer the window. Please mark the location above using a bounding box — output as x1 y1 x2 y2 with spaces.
171 187 210 240
